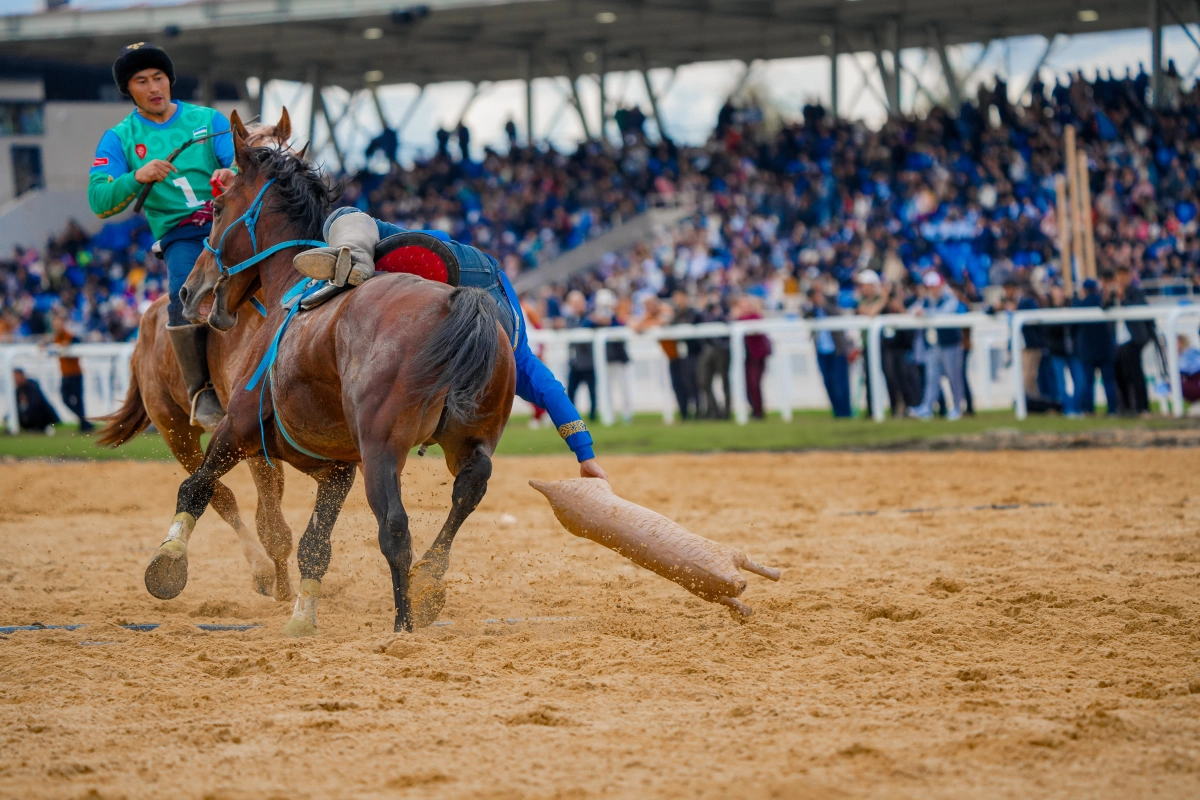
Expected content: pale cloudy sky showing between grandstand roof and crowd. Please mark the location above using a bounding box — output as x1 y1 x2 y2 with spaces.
9 0 1200 167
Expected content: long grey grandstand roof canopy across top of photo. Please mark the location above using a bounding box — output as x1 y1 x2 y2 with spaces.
0 0 1180 146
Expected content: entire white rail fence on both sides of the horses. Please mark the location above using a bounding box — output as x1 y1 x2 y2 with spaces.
0 305 1200 433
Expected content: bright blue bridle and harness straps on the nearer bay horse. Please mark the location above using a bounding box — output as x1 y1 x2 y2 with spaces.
204 172 330 467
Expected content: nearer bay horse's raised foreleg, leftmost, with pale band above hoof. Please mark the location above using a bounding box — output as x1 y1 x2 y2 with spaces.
145 417 242 600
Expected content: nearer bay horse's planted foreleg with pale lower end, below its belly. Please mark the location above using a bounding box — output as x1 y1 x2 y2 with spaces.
283 463 354 636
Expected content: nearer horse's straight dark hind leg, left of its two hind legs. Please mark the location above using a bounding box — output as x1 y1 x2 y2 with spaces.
362 449 413 633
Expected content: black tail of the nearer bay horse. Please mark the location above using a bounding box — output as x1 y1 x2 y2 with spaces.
416 287 500 425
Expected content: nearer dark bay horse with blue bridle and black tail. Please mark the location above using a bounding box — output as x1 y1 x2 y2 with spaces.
146 115 516 634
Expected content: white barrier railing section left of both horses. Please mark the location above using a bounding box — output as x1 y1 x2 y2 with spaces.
0 342 134 433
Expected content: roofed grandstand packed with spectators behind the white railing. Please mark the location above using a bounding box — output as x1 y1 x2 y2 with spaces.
0 0 1200 419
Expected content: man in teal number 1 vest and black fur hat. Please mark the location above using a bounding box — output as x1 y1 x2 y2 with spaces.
88 42 234 431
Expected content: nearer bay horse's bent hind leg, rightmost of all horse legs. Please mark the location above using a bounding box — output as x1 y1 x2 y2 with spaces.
408 443 492 627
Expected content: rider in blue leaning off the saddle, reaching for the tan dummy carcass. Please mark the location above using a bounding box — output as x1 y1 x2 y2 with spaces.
296 207 608 480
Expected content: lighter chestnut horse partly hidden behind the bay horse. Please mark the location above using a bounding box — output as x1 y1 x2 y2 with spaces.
97 109 304 600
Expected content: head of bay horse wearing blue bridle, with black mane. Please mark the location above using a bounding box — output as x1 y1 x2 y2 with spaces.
179 109 332 331
